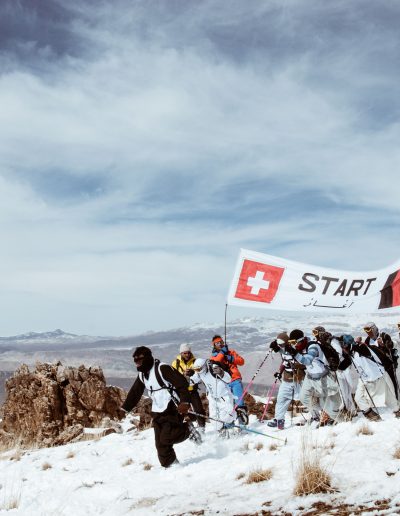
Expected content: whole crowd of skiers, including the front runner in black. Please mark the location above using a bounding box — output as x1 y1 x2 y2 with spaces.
122 322 400 468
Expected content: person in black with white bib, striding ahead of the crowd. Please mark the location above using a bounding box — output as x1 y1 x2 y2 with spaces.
122 346 194 468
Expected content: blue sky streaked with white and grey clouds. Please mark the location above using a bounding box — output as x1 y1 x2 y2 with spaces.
0 0 400 336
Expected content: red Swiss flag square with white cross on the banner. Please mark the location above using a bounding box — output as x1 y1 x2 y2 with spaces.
235 260 285 303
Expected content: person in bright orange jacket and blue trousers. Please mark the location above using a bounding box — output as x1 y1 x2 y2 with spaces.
211 335 249 425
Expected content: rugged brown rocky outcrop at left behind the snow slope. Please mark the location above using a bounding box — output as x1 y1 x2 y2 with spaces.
0 362 126 446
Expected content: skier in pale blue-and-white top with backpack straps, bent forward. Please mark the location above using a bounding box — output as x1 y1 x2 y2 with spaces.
285 329 341 426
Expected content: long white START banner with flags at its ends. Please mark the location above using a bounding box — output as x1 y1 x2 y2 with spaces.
228 249 400 313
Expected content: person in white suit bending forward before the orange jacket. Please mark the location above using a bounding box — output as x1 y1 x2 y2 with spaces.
190 358 236 430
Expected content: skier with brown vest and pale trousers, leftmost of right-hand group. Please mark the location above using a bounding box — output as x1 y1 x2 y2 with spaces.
267 332 305 430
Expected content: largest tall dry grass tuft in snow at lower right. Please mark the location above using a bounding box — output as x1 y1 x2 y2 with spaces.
294 432 334 496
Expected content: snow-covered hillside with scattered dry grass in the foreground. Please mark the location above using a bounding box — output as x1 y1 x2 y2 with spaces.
0 413 400 516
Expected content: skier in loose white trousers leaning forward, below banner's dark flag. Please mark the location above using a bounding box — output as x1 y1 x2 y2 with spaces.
343 336 400 421
